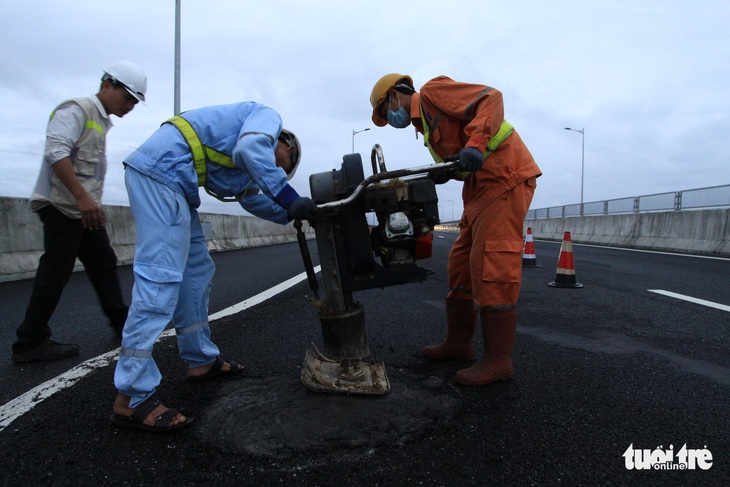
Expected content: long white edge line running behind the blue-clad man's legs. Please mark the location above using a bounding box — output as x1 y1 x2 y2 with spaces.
0 266 320 431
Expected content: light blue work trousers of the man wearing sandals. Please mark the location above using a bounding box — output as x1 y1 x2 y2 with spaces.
114 166 220 408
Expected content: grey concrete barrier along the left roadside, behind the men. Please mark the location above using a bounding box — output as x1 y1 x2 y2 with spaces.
0 197 314 282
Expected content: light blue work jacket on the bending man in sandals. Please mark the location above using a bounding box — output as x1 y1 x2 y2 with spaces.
124 102 299 224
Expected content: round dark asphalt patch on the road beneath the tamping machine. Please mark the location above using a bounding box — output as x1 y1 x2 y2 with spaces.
199 368 457 458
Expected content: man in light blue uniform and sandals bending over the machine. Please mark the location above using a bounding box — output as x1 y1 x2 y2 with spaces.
111 102 317 431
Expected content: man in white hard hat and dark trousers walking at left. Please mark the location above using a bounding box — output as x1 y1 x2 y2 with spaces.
12 61 147 362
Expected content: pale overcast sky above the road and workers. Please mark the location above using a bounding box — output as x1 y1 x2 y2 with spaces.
0 0 730 220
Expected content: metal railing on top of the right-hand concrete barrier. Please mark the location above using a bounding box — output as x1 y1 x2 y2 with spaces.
527 184 730 219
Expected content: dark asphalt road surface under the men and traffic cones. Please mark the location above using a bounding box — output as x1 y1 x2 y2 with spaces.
0 233 730 486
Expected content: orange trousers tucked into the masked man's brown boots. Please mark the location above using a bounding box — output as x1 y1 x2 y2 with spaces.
448 178 535 307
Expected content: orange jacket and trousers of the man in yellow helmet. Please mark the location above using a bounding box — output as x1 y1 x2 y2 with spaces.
411 76 541 306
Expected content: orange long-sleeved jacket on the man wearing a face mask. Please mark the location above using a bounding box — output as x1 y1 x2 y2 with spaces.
410 76 542 225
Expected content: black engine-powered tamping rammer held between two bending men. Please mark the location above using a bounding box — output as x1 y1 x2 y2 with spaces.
295 144 456 395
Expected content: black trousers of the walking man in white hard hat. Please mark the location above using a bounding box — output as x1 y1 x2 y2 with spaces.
13 206 128 352
